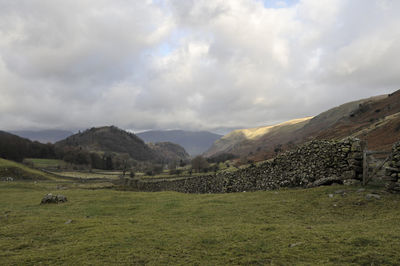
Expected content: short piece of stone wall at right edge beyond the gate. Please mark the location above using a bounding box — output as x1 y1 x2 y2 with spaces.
386 142 400 193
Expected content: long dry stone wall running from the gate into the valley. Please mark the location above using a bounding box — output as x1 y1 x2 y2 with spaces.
125 138 363 193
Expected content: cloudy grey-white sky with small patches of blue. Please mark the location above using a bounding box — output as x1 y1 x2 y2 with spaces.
0 0 400 132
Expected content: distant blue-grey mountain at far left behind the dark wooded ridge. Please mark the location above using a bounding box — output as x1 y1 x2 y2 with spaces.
11 130 74 143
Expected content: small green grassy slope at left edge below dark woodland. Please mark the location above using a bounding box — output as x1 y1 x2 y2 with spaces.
0 158 55 180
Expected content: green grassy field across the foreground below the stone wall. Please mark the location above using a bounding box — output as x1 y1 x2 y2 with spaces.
0 182 400 265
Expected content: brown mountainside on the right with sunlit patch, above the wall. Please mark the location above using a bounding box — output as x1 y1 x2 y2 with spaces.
205 90 400 161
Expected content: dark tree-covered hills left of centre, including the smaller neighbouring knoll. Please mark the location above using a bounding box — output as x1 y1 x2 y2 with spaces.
55 126 189 162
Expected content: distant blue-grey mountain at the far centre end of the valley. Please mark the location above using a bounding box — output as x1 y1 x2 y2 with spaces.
137 130 222 156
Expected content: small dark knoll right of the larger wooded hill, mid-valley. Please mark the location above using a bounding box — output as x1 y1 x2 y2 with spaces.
148 142 190 162
